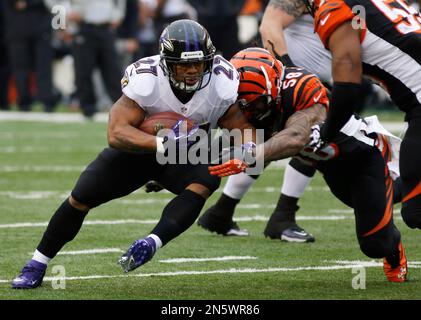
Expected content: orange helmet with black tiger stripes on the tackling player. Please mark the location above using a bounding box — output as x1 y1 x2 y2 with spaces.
230 47 285 121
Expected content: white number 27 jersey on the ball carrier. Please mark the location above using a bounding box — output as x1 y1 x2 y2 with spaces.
122 55 239 130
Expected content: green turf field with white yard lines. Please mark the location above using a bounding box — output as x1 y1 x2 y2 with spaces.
0 118 421 300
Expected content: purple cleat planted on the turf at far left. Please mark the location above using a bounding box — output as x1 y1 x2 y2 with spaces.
12 260 47 289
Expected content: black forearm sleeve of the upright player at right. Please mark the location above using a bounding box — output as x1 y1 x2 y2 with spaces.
320 82 361 141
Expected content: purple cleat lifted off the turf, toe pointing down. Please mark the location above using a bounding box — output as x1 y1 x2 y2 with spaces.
118 237 156 272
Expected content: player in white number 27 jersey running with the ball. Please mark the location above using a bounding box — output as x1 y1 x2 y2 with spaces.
12 20 255 289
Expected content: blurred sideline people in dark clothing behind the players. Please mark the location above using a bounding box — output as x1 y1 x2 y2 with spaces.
0 0 416 118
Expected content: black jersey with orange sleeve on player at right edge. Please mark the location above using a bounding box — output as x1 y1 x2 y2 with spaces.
315 0 421 112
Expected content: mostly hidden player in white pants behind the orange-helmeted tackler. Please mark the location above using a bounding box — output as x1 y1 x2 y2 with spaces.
199 0 331 243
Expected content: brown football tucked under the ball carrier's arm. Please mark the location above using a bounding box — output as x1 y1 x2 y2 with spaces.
139 111 194 136
